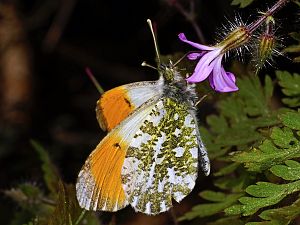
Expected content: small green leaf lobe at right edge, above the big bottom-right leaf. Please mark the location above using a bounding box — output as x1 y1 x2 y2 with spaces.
270 160 300 181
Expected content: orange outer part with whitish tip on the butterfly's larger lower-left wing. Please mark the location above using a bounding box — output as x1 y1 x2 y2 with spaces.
76 132 129 211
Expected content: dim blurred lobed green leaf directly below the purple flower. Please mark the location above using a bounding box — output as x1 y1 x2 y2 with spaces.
208 77 279 149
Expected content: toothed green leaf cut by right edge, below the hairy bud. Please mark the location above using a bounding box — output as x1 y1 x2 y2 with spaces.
276 71 300 107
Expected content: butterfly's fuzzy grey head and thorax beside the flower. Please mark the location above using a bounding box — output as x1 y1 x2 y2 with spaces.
159 64 198 109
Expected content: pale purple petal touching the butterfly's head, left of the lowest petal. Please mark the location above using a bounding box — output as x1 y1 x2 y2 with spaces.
186 50 220 83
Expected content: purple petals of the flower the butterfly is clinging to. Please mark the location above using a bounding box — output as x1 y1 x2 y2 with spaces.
178 33 238 92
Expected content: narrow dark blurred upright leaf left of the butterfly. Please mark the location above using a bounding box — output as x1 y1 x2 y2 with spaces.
30 140 60 195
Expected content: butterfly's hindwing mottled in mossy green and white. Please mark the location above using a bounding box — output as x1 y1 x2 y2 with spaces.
122 98 198 215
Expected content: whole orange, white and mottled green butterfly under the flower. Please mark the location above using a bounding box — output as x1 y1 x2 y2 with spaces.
76 21 210 215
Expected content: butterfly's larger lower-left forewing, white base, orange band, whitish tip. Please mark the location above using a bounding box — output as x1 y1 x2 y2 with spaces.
76 98 161 211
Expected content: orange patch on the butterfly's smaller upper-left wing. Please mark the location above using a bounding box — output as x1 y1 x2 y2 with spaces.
96 86 135 131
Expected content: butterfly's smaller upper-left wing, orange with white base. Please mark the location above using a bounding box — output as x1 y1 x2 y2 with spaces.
96 80 162 131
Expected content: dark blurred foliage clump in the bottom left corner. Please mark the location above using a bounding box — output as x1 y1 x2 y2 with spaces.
4 141 101 225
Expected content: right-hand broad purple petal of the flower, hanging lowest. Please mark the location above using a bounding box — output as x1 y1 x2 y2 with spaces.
209 57 239 92
